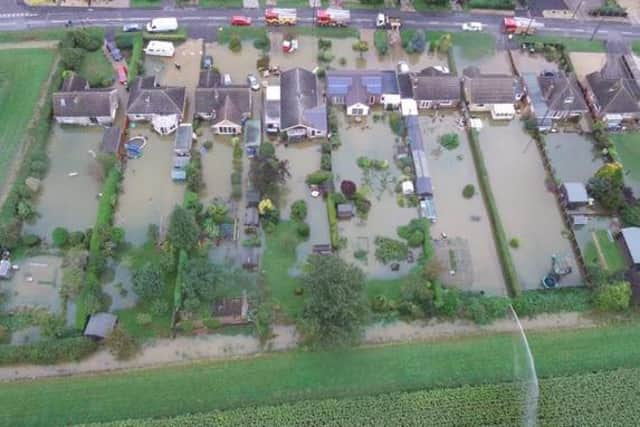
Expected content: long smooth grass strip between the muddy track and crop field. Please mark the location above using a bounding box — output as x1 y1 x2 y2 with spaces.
0 321 640 426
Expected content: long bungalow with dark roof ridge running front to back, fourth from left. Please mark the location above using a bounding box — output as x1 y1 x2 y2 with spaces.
280 68 327 141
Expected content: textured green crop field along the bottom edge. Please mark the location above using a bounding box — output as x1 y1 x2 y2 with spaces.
82 369 640 427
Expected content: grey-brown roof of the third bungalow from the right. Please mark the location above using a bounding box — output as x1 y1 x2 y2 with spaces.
463 67 520 104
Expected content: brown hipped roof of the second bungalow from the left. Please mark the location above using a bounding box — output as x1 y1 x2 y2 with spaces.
127 77 186 115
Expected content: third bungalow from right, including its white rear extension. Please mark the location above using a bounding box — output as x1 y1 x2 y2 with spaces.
462 67 523 120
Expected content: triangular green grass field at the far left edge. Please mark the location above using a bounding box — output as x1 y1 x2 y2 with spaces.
0 49 56 191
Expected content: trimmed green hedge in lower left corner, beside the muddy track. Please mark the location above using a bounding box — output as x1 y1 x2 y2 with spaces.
0 337 98 365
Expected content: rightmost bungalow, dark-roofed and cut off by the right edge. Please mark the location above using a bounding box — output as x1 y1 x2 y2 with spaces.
585 55 640 128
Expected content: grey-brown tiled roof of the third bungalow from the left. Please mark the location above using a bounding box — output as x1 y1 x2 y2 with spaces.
195 86 251 124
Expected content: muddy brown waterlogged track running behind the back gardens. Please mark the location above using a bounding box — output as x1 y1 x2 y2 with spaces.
0 313 597 381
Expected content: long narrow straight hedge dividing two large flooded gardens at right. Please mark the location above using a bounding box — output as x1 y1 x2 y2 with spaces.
467 129 522 297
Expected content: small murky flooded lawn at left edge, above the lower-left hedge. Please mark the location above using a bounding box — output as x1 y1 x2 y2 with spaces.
0 256 62 314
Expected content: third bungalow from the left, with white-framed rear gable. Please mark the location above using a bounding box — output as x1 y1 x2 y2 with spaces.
195 85 251 135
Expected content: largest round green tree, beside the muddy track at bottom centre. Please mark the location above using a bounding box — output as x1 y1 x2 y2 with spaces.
302 255 369 347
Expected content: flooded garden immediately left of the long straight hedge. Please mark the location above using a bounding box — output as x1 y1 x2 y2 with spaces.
420 113 506 295
